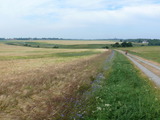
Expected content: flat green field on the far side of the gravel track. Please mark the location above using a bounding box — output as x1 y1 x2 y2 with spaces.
121 46 160 63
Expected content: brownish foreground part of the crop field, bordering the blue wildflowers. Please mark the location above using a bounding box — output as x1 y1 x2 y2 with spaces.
0 52 109 120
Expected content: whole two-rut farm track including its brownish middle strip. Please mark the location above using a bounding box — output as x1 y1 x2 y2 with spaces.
118 50 160 86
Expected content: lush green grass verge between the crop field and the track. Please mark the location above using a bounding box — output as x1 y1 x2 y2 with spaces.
81 53 160 120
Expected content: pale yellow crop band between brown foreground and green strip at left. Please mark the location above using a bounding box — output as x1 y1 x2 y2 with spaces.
0 57 80 81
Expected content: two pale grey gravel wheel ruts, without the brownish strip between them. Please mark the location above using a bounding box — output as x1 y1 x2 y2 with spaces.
117 50 160 86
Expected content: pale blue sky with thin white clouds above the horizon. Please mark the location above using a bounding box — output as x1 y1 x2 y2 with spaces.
0 0 160 39
